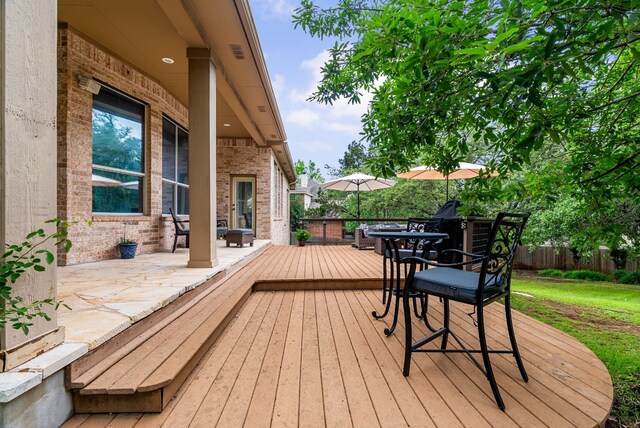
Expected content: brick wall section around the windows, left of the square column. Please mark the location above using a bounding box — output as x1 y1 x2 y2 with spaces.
58 27 188 264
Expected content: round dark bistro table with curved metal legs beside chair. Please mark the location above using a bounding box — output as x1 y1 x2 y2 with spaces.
368 231 449 336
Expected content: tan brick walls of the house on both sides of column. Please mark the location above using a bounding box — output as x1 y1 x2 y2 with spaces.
58 26 288 265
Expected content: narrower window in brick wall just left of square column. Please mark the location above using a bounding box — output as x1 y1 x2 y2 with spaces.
162 117 189 214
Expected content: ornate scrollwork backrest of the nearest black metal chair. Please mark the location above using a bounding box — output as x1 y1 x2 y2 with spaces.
478 212 531 296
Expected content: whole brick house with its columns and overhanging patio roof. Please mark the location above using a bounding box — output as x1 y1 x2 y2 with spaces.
0 0 296 394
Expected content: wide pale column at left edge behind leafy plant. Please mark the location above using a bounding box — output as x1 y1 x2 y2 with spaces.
0 0 62 370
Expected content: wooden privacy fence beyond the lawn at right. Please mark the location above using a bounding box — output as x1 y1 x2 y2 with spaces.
514 246 638 274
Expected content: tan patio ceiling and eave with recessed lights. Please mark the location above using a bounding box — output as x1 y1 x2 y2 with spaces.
58 0 295 181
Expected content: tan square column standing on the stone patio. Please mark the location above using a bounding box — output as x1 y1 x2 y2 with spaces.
187 48 218 268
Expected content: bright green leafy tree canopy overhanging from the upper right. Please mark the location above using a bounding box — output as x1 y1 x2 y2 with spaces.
294 0 640 252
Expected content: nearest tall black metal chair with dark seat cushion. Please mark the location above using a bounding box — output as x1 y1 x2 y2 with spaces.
403 212 530 410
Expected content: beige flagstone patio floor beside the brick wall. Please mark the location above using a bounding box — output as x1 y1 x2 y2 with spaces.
58 240 271 350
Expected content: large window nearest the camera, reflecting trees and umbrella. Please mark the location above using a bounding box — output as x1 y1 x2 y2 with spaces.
91 86 145 214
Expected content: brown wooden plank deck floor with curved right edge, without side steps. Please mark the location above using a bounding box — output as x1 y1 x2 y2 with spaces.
65 246 613 427
